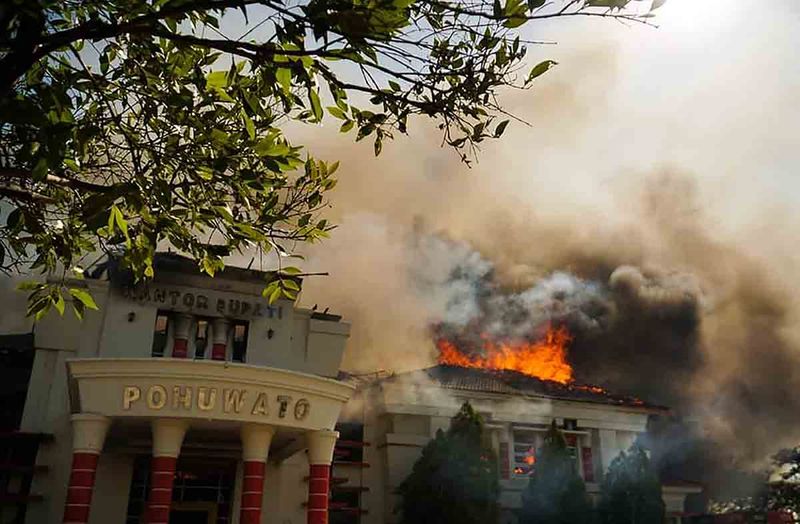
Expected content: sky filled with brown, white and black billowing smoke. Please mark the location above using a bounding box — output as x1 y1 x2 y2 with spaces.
282 0 800 457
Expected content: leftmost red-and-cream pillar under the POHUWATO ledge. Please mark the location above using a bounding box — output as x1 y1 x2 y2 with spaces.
63 413 111 524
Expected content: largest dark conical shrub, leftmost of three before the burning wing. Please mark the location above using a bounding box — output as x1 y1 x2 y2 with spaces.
397 402 499 524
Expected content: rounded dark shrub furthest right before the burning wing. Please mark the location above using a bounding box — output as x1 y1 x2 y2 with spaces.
598 444 665 524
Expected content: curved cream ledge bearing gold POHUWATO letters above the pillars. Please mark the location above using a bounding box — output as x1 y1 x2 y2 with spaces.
67 358 354 430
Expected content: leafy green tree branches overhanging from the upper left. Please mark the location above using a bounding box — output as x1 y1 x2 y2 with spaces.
0 0 663 315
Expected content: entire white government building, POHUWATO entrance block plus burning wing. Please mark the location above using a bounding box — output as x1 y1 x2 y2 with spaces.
0 254 699 524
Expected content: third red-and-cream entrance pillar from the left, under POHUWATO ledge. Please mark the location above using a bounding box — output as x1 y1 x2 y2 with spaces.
239 424 275 524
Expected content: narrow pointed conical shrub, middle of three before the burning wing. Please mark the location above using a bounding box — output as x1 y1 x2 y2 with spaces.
519 421 593 524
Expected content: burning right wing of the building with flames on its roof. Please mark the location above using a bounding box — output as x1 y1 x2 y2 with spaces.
333 327 701 524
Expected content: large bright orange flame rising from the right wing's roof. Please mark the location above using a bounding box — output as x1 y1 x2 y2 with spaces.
436 326 573 384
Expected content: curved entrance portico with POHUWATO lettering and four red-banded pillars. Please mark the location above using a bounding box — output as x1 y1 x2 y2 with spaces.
63 359 352 524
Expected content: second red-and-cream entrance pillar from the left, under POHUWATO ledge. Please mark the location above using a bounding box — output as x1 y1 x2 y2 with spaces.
145 418 189 524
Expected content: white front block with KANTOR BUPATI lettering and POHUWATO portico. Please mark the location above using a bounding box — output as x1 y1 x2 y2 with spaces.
0 255 353 524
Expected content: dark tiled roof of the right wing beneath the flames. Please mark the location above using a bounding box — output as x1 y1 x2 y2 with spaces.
386 365 668 411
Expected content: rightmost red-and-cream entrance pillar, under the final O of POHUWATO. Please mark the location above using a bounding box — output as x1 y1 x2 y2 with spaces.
306 429 339 524
